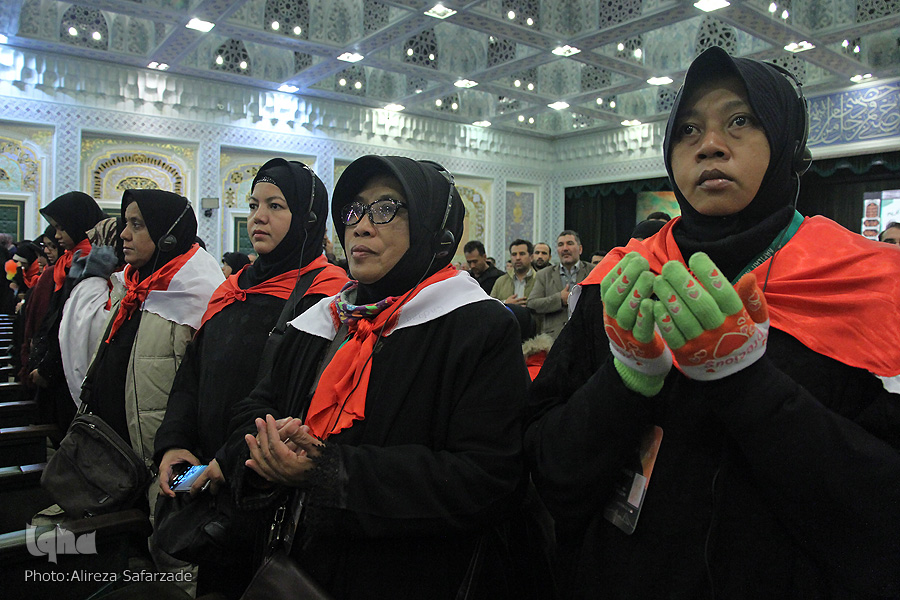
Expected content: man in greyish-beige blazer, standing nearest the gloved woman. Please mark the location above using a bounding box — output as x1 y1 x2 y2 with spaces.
527 229 594 339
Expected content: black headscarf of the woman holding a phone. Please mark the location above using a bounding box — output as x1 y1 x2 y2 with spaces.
238 158 328 289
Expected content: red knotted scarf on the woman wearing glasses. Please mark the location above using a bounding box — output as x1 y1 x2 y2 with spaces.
306 266 457 439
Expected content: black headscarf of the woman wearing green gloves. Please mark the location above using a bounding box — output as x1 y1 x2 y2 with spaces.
663 47 806 277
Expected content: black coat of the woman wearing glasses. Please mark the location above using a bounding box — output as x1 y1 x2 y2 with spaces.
220 300 528 600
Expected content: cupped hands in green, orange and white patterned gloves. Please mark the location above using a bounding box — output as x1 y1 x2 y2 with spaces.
600 252 769 397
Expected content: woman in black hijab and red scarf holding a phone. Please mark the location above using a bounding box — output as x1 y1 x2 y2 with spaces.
149 158 347 597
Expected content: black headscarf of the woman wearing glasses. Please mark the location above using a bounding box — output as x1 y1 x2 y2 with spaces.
331 155 466 304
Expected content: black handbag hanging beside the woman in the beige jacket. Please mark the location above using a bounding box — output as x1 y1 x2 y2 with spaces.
41 412 151 518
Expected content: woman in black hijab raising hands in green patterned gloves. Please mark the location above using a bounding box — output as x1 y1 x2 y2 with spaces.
525 48 900 598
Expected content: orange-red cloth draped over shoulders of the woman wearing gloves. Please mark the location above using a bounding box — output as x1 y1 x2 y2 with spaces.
582 217 900 377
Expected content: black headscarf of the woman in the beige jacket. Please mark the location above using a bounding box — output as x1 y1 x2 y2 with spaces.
122 190 197 280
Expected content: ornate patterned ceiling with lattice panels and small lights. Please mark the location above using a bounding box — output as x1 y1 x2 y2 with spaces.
0 0 900 137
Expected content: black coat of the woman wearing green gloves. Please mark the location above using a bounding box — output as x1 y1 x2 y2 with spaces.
525 285 900 599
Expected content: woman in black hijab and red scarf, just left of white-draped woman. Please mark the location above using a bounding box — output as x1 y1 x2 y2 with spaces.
28 192 106 443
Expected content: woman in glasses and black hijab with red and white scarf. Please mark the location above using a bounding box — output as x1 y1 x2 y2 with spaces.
217 156 528 599
